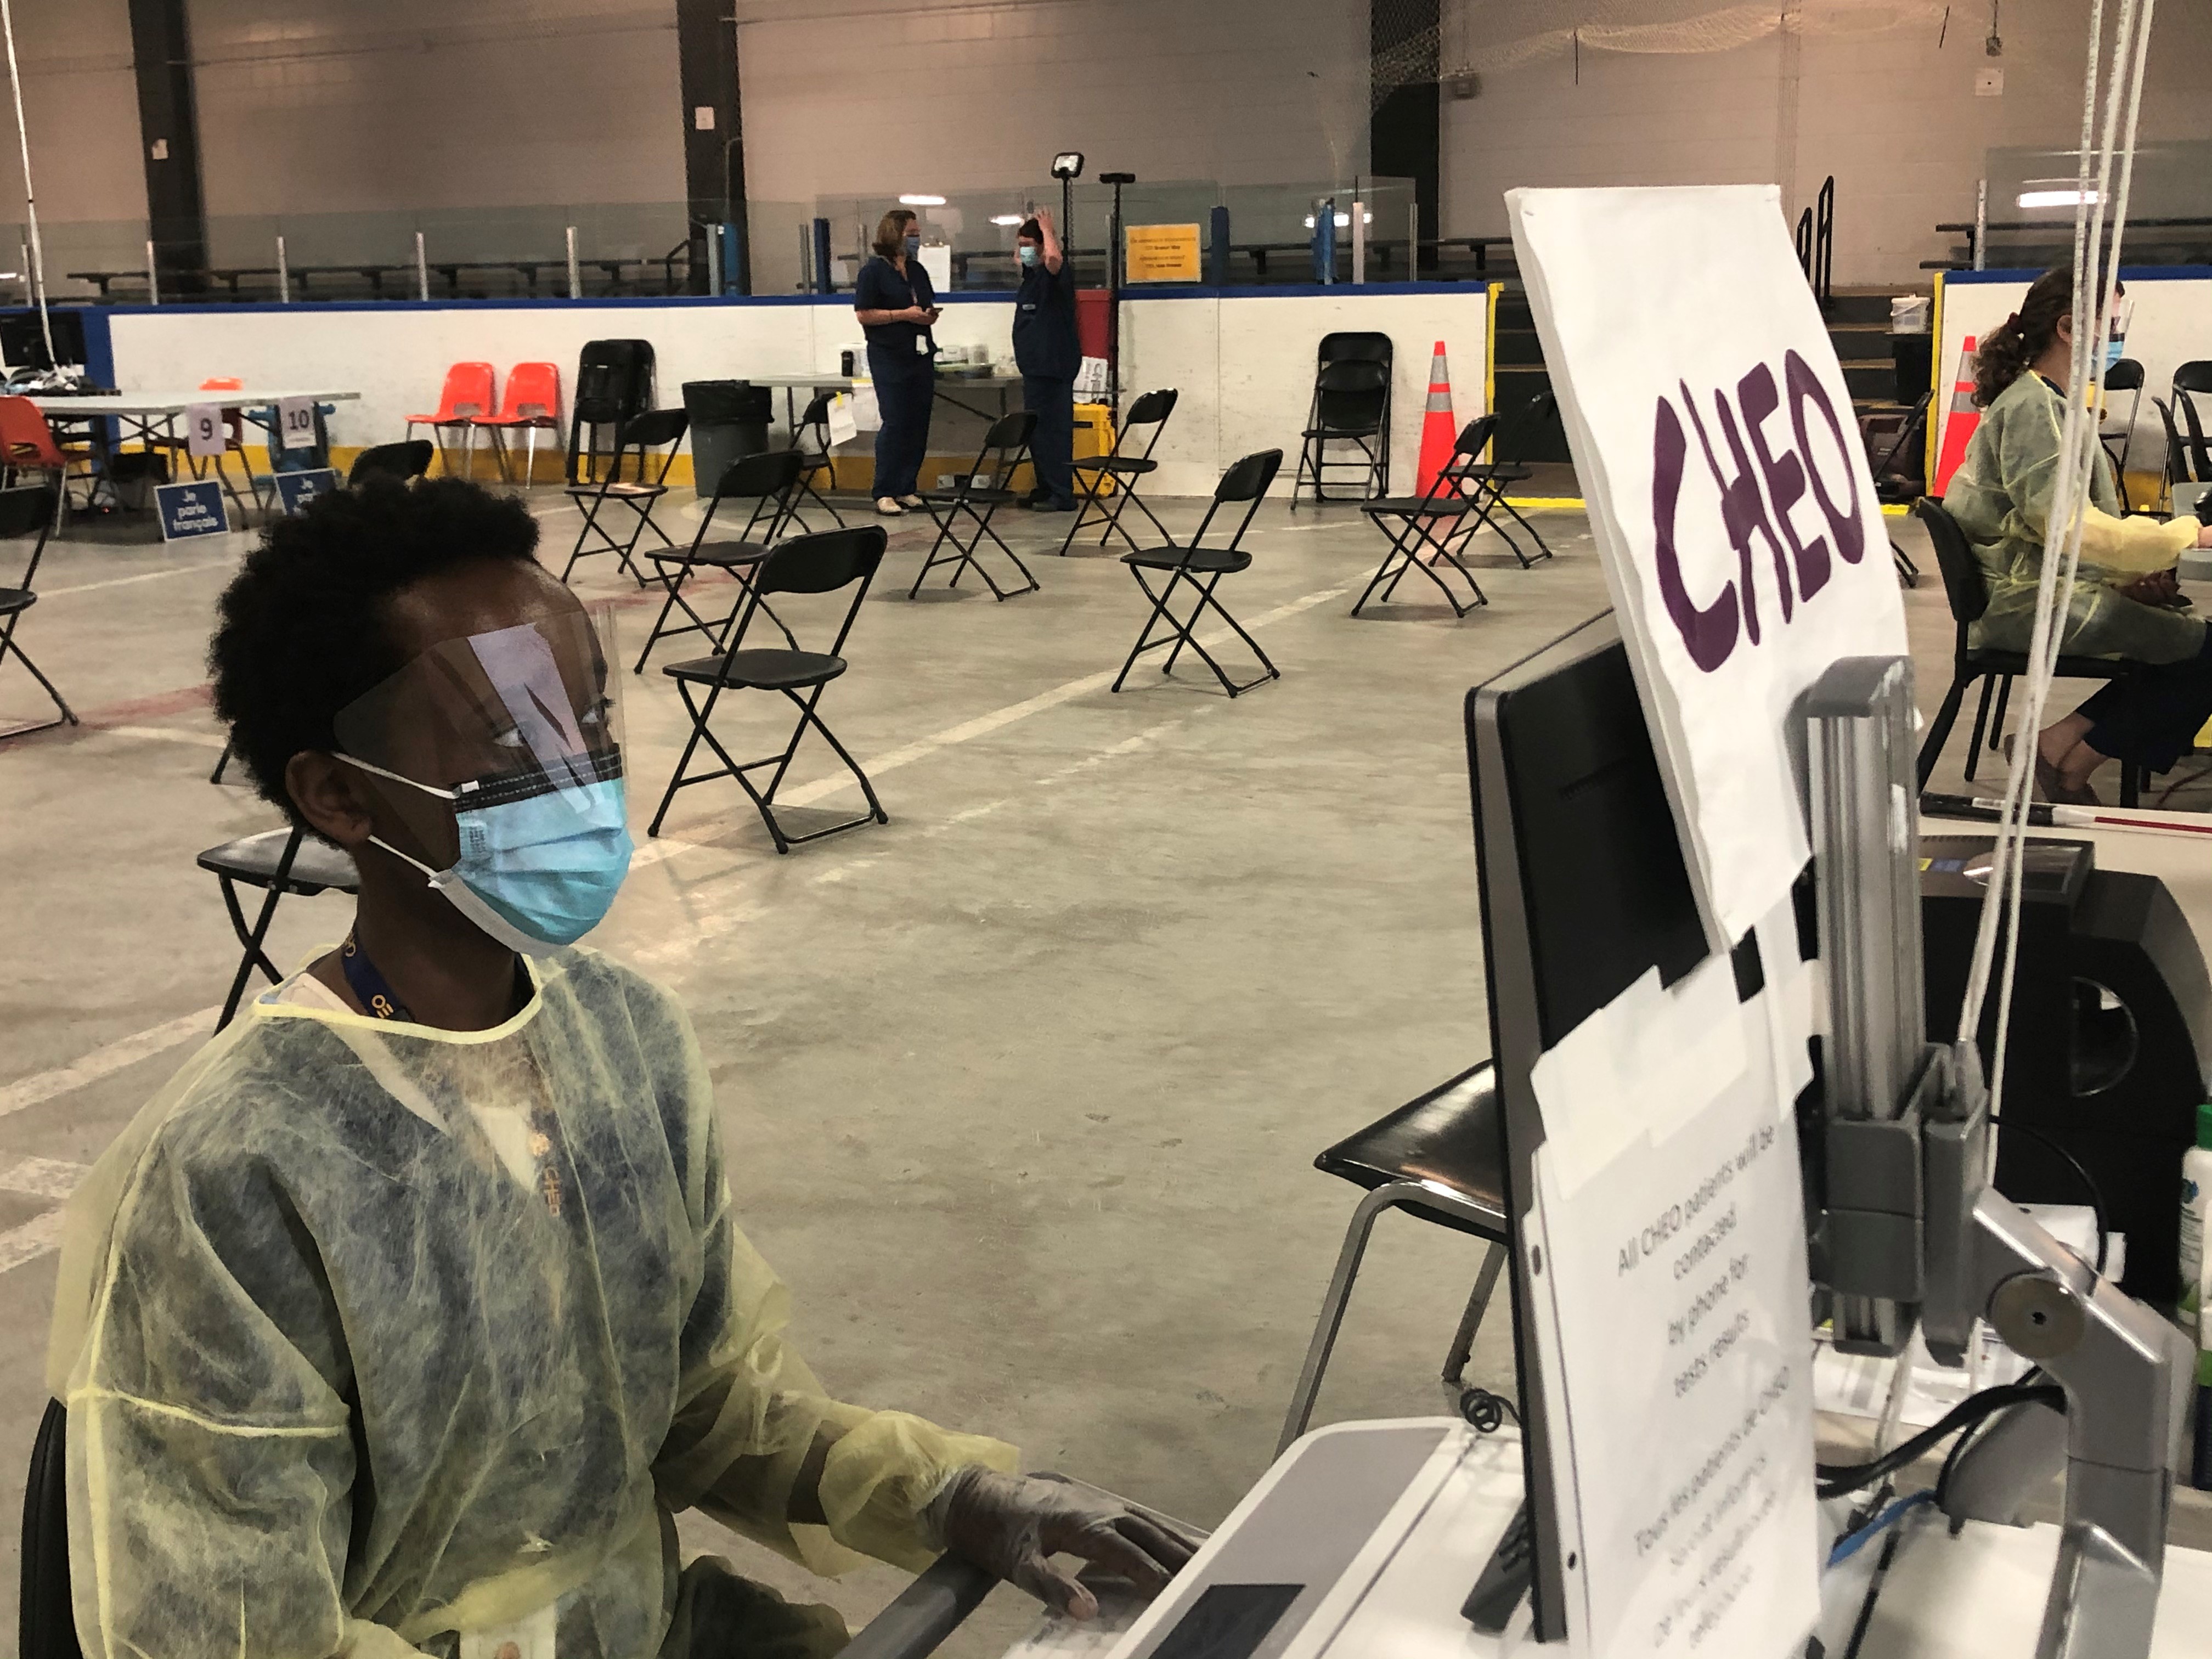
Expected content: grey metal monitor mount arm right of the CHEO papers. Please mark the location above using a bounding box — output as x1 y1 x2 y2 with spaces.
1805 657 2190 1659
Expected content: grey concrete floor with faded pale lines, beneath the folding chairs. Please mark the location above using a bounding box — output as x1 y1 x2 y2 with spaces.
0 495 2212 1655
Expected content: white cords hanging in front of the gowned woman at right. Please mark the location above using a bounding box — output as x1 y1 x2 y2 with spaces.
1960 0 2154 1155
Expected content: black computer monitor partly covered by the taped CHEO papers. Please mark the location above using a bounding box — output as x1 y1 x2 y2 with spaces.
1466 611 1708 1641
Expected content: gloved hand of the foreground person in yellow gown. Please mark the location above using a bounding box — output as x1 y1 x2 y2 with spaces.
922 1464 1197 1619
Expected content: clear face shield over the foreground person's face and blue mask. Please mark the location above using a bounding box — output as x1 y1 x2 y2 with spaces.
336 611 633 956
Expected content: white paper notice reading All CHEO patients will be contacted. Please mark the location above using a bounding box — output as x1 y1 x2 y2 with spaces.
1533 911 1820 1659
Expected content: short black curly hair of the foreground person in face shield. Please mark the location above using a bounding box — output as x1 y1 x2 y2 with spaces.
208 478 538 823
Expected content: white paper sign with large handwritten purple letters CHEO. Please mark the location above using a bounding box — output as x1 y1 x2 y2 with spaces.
1506 186 1907 949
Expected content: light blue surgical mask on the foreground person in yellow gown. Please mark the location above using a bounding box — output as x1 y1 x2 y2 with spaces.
338 754 635 956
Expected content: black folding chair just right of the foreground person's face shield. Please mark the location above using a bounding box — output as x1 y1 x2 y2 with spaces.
646 524 889 851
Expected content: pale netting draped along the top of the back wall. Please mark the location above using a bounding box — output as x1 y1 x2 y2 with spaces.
1372 0 1973 99
